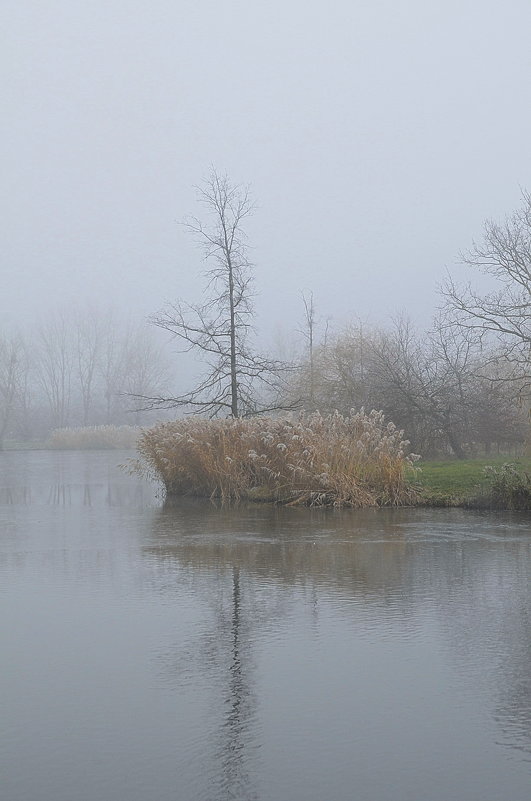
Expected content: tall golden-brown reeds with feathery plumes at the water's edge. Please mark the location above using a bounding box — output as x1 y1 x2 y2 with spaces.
133 409 417 507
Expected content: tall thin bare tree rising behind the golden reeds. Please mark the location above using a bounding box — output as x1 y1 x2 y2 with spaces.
141 170 290 417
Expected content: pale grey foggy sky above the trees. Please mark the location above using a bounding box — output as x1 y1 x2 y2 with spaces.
0 0 531 340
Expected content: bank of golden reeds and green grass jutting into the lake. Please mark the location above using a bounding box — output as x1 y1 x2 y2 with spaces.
132 411 531 510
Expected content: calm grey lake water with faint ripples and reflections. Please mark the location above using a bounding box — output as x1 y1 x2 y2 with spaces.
0 452 531 801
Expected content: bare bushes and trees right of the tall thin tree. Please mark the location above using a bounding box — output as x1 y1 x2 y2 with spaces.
284 192 531 458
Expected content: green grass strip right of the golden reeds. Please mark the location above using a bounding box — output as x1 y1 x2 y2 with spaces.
418 456 531 509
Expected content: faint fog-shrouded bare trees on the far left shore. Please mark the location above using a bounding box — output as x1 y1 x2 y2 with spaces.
0 309 172 447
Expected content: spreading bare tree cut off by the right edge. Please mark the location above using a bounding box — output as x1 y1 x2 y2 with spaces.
442 192 531 388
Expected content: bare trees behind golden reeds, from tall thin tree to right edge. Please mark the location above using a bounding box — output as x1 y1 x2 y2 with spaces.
139 170 531 458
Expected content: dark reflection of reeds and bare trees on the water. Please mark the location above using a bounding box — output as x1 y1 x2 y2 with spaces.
146 501 531 776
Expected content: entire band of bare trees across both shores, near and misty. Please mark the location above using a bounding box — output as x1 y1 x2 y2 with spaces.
0 170 531 458
